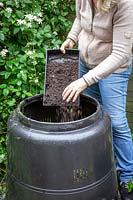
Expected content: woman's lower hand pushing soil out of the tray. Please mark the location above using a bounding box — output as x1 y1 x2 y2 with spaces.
62 78 88 102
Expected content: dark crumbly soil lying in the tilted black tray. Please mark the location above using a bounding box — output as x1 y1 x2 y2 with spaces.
44 59 79 107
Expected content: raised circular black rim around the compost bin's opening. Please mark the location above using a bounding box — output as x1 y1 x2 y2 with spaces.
16 94 103 132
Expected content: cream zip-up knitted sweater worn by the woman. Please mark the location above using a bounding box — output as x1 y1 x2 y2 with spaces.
68 0 133 85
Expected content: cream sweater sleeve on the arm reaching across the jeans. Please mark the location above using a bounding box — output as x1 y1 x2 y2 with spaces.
84 0 133 85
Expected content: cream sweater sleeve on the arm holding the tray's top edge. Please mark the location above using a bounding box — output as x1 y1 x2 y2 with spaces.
67 0 81 43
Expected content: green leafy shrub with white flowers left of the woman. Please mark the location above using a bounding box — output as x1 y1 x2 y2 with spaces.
0 0 75 181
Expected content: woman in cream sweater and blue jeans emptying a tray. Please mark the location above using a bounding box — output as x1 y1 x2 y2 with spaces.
61 0 133 200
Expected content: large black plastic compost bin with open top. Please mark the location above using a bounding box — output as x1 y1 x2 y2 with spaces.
7 95 117 200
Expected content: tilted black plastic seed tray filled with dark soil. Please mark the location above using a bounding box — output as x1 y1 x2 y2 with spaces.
43 49 79 106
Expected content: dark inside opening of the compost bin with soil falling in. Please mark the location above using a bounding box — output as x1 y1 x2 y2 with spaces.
21 95 98 123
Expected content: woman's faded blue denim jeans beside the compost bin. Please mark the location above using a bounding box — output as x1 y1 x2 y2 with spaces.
80 61 133 182
